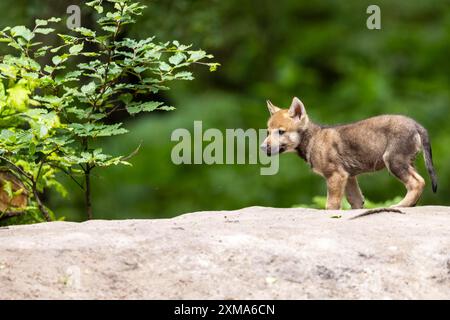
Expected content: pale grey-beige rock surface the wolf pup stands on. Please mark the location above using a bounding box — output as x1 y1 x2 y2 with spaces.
0 207 450 299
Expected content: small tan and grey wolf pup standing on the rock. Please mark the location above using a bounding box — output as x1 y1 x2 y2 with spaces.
261 98 437 209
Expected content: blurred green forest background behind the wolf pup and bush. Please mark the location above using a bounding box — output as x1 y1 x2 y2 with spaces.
0 0 450 220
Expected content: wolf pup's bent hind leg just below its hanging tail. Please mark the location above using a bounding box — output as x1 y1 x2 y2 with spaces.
385 158 425 207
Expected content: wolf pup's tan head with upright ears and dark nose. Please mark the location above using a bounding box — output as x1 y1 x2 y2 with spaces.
261 97 309 156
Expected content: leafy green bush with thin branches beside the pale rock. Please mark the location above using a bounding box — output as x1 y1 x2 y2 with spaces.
0 0 218 222
